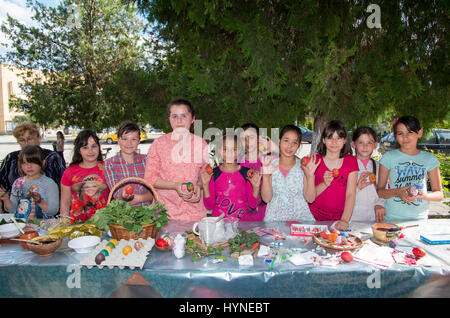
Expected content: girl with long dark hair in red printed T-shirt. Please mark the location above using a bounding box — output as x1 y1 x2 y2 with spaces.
60 129 109 221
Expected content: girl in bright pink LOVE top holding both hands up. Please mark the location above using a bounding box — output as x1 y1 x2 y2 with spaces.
201 135 261 221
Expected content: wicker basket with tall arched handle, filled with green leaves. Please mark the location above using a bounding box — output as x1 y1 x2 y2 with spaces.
108 177 158 240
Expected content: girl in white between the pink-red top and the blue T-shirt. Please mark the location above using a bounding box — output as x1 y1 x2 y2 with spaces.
352 126 386 223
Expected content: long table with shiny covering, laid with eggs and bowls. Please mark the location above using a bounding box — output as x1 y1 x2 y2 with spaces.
0 219 450 298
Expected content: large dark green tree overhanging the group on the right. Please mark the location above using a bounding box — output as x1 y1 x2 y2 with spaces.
138 0 448 147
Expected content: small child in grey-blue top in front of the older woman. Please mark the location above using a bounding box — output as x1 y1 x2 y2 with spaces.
0 146 59 219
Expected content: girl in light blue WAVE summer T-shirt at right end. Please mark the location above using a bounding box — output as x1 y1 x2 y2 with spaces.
377 116 444 220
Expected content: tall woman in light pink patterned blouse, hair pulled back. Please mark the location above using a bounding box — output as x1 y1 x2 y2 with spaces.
144 99 208 222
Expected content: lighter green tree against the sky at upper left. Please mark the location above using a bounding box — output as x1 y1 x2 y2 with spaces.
2 0 148 130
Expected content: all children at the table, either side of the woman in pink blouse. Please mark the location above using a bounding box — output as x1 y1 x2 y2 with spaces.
0 116 443 229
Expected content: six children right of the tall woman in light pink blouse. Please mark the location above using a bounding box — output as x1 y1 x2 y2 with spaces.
201 116 443 229
